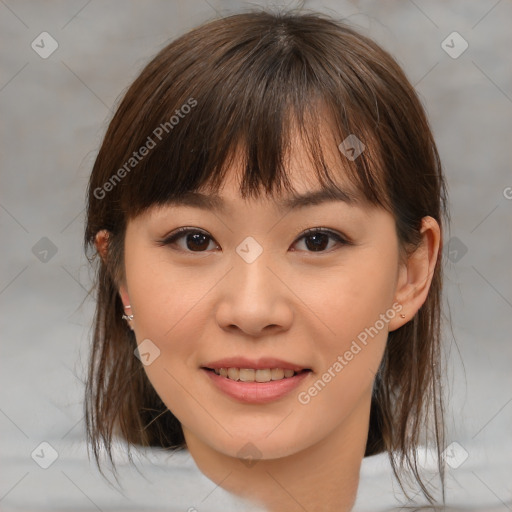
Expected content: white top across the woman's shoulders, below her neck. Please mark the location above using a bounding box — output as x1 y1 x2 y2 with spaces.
0 428 512 512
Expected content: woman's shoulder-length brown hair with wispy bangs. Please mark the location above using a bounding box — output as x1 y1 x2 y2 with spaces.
84 12 447 503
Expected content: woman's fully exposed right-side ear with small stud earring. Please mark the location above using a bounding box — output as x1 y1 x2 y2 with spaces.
389 217 441 331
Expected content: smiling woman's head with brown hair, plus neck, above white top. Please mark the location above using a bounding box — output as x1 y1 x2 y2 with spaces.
85 12 445 512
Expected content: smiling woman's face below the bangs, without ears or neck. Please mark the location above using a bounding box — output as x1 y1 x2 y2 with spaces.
120 139 404 459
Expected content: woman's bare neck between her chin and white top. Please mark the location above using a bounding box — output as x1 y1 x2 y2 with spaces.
183 401 370 512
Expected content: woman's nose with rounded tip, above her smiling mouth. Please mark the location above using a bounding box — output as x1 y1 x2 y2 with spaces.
216 252 293 337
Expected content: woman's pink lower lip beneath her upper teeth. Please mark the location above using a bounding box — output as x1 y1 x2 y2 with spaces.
201 368 311 404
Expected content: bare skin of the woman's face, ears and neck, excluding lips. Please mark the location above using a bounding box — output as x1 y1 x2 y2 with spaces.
96 130 440 512
